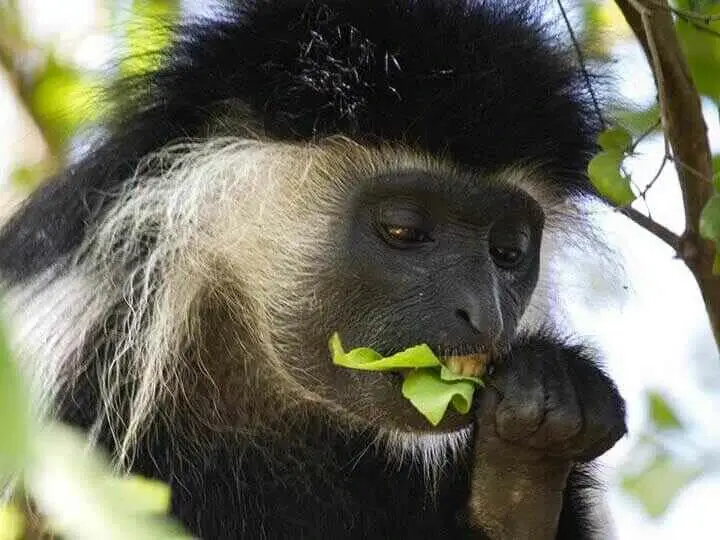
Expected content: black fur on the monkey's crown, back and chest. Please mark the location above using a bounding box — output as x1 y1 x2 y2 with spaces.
0 0 620 540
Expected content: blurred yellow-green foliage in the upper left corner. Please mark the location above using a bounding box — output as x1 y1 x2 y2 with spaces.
0 0 180 189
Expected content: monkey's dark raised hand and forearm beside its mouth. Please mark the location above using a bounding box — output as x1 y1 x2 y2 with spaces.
469 337 626 540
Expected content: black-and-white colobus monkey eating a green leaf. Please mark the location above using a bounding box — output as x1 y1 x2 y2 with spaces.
0 0 625 540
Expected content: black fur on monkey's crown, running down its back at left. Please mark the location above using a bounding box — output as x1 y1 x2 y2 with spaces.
0 0 597 282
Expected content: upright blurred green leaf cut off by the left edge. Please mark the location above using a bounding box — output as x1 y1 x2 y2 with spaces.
0 318 30 474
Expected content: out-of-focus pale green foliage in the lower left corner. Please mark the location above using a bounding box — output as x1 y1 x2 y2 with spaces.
0 308 190 540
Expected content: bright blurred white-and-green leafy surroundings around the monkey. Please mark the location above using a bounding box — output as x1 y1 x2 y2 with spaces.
0 0 720 540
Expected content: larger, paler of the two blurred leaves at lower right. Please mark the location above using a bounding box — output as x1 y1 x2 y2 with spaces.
622 454 702 517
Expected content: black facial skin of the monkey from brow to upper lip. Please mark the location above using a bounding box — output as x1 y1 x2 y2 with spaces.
348 172 543 354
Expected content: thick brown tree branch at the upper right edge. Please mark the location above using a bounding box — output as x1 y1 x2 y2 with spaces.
616 0 720 347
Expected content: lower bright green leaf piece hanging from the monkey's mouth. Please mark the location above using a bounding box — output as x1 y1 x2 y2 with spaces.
402 369 475 426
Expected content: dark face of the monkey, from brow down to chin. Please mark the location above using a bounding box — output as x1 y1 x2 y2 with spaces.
278 170 544 431
